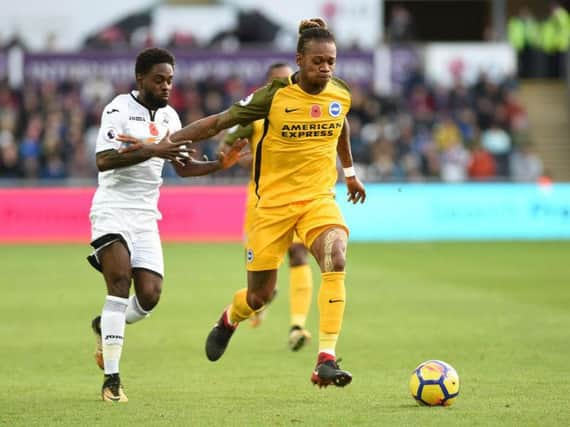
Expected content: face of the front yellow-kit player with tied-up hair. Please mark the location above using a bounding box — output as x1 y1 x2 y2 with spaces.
297 40 336 89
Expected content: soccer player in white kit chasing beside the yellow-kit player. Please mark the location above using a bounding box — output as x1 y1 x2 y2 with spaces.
88 48 247 402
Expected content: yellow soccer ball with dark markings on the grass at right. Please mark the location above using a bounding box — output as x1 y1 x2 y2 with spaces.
410 360 459 406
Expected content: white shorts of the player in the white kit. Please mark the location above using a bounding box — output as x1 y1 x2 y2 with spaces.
90 209 164 276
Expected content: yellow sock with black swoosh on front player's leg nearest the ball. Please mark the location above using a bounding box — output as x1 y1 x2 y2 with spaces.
319 271 346 354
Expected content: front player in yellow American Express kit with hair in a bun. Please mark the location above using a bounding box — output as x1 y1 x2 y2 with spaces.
123 18 366 387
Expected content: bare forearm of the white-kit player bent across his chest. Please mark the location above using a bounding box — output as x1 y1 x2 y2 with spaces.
96 135 195 172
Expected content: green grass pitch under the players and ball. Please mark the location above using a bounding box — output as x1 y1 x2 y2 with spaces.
0 242 570 426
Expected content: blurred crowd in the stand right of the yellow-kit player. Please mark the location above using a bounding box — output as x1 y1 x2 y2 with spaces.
349 73 543 182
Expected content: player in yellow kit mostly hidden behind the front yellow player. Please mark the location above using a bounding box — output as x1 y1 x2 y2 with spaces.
222 62 313 351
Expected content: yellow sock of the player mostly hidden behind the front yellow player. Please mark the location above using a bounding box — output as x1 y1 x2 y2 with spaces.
289 264 313 328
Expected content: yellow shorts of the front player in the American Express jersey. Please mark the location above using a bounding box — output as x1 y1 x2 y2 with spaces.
246 198 348 271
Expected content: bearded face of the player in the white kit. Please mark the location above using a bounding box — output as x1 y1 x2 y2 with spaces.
137 63 174 110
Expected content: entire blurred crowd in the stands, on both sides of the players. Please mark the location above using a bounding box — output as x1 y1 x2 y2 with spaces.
0 68 543 182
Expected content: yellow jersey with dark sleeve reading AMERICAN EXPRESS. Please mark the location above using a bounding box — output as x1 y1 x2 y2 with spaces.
229 74 351 207
